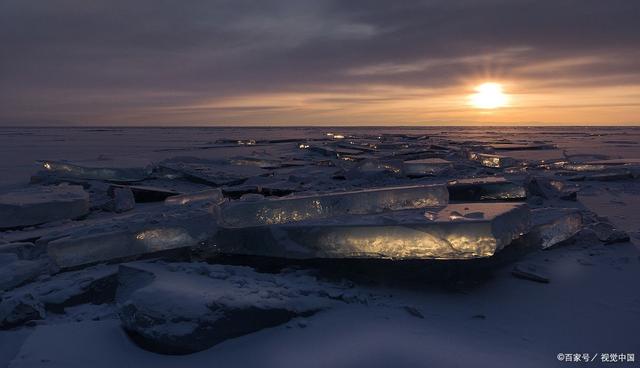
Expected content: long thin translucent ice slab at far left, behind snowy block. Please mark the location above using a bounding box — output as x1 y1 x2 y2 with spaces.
41 161 151 182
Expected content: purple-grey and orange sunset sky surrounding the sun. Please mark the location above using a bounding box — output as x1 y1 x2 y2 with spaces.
0 0 640 126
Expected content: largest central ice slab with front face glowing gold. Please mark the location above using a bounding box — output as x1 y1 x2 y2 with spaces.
214 203 530 259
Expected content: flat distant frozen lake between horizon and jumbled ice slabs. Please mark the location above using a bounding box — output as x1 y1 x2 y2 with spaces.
0 126 640 188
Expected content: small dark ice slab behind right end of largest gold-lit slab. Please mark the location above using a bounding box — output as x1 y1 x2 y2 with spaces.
447 176 527 201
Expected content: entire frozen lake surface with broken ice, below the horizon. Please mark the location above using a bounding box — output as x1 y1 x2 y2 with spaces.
0 127 640 367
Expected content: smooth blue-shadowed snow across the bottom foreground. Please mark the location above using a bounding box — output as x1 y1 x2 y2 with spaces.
5 240 640 367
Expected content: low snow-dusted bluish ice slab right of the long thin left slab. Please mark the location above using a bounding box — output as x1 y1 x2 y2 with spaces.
158 157 268 186
